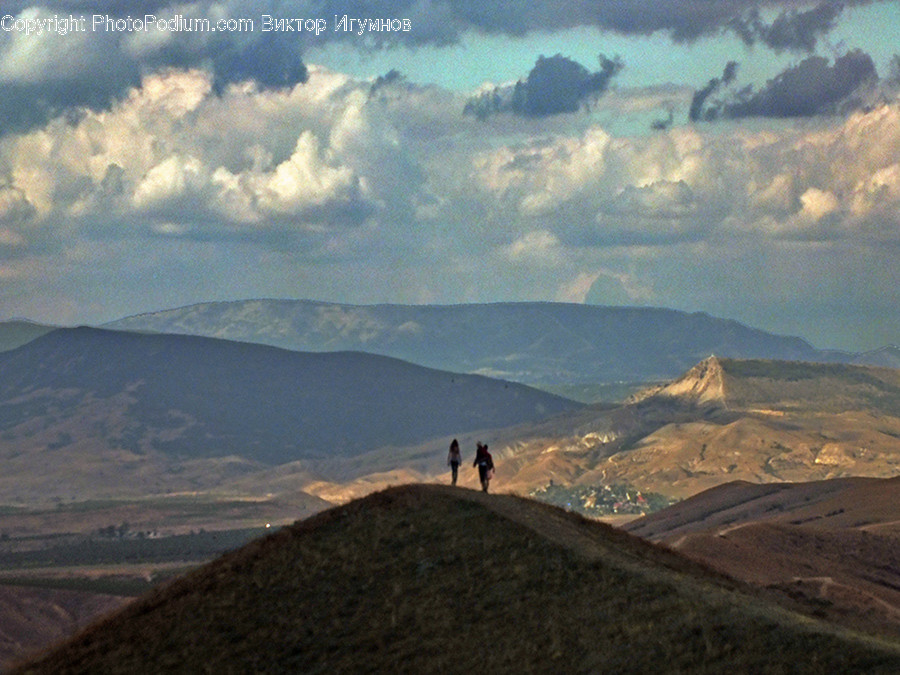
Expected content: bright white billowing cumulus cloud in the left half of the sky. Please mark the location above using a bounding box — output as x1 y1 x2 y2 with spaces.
0 64 420 242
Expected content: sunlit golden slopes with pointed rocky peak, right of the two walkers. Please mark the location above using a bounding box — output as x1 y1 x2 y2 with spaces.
486 357 900 498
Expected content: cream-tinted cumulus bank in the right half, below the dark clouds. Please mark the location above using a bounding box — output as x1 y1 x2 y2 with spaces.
474 92 900 257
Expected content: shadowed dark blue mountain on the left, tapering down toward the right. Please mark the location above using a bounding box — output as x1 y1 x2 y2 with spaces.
0 328 579 504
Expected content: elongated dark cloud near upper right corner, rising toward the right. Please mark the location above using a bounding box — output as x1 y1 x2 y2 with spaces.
690 50 878 121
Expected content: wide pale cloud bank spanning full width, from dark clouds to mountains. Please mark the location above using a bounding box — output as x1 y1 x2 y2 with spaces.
0 36 900 348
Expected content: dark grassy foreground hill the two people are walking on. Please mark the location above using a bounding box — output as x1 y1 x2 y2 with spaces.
12 486 900 673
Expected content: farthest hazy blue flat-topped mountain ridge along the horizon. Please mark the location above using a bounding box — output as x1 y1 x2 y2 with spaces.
109 300 846 385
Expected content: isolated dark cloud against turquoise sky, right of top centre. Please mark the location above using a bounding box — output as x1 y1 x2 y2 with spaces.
465 54 622 119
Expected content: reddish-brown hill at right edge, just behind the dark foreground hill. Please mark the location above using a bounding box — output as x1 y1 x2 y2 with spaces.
626 478 900 636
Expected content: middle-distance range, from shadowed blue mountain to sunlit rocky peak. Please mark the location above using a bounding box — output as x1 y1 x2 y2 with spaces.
0 320 900 510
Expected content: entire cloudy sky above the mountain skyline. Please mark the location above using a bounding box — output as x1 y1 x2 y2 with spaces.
0 0 900 351
